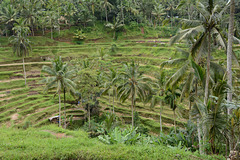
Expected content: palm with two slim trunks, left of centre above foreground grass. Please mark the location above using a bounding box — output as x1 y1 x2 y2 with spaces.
42 57 76 127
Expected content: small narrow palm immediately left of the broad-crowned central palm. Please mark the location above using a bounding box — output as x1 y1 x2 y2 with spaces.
103 68 118 113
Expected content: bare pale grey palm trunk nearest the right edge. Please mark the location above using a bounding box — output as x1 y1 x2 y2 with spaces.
227 0 235 114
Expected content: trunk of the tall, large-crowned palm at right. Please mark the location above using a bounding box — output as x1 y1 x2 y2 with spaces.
204 31 211 105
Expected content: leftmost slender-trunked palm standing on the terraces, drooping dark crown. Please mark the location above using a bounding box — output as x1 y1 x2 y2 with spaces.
10 20 32 85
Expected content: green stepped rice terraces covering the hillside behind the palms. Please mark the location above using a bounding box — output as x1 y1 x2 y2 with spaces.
0 37 238 133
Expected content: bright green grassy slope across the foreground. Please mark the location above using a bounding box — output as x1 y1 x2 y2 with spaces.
0 125 224 160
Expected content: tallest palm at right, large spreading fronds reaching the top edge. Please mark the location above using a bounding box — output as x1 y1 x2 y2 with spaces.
170 0 232 105
